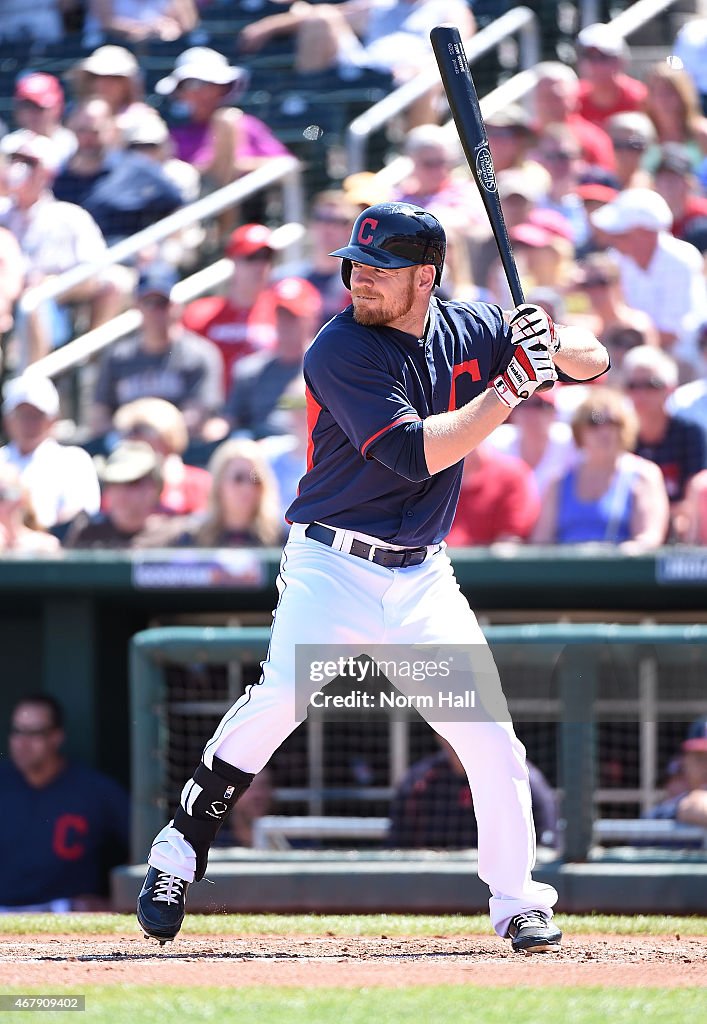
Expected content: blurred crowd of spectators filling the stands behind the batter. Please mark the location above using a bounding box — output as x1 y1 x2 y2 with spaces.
0 6 707 553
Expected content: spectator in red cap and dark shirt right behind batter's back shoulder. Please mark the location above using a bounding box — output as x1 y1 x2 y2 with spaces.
225 278 322 440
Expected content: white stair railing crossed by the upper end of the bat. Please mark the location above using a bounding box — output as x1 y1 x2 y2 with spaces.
346 7 540 173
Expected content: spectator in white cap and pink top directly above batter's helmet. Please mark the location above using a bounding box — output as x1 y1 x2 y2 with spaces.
393 124 486 226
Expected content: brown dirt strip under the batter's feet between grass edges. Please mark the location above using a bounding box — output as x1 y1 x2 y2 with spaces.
0 934 707 990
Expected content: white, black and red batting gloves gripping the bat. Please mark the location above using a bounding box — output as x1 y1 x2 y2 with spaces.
492 305 559 409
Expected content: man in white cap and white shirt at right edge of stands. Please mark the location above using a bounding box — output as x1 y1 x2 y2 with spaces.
591 188 707 362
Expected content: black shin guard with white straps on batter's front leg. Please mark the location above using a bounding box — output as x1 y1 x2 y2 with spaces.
174 757 255 882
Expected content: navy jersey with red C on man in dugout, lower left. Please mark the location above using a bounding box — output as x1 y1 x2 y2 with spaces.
0 760 129 906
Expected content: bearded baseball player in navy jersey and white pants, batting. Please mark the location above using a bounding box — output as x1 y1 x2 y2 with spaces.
137 203 609 951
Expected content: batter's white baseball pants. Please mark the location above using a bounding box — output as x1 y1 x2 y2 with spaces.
150 523 557 936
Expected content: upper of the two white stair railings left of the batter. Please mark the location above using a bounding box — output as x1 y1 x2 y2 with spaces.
19 151 304 313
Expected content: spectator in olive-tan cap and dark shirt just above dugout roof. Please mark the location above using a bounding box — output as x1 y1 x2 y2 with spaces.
64 441 188 549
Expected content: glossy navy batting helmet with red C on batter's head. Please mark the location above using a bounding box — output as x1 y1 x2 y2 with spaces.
329 203 447 288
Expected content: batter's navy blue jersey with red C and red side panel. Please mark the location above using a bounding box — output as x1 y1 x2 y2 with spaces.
287 299 512 547
